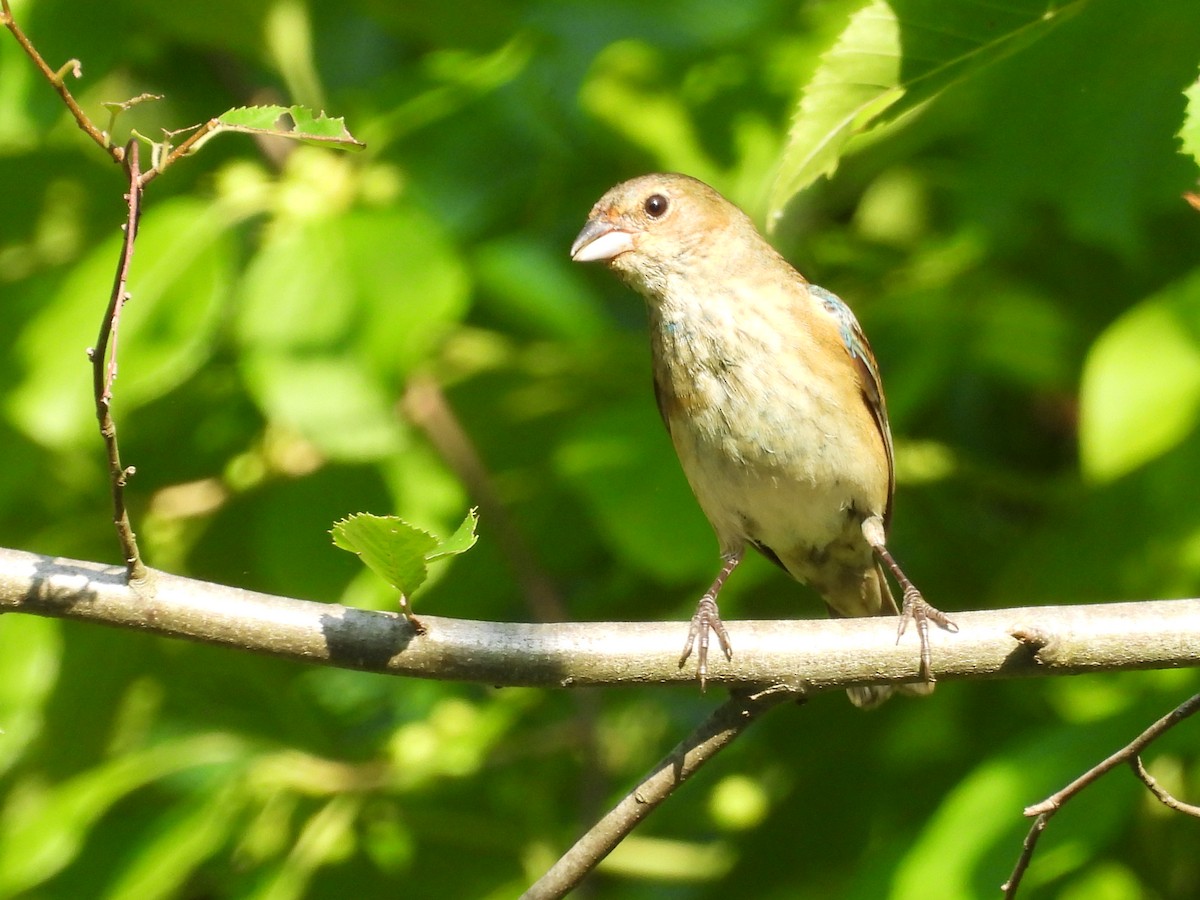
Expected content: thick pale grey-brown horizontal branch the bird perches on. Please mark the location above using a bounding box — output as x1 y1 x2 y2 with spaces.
0 550 1200 692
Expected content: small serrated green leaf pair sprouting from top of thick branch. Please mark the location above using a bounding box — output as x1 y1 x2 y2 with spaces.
330 510 479 598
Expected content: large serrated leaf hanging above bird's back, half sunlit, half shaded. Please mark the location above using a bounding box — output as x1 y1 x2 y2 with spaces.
769 0 1087 223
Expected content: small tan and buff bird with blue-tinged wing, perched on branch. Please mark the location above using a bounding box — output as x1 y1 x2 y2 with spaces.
570 173 958 708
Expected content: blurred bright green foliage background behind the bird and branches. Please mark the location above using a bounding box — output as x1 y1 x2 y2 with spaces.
0 0 1200 900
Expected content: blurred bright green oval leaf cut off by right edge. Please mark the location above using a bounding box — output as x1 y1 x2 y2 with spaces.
1079 272 1200 481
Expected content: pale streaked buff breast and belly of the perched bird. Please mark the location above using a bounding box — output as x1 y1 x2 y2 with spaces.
652 300 888 553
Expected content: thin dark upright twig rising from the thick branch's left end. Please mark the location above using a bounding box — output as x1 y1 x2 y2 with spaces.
88 138 146 580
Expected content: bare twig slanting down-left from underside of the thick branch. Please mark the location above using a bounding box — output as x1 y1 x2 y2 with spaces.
522 686 804 900
